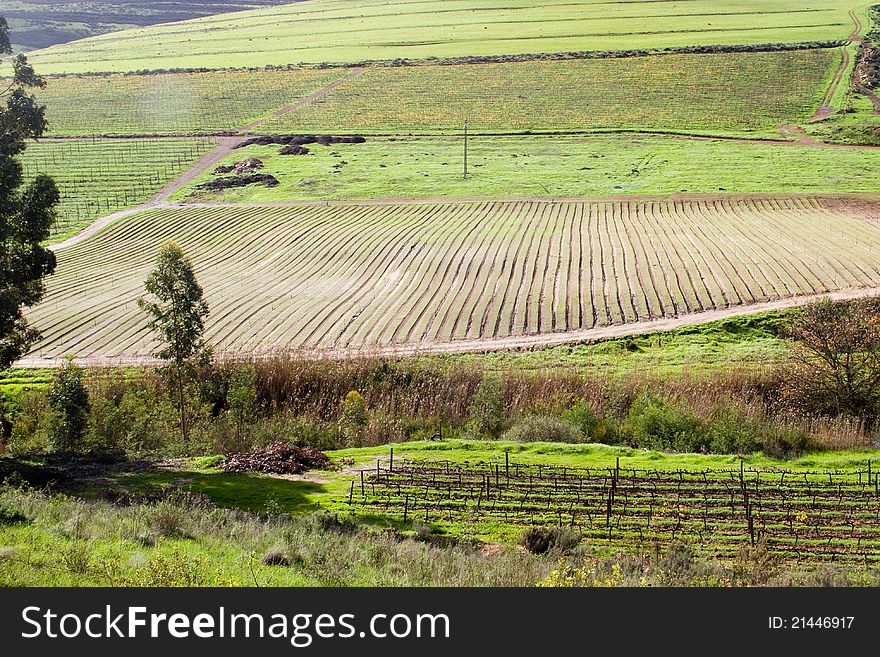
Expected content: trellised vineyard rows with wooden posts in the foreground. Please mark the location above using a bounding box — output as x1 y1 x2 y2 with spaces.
347 451 880 564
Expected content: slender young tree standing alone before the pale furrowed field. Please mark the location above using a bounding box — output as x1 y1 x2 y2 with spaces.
138 242 208 442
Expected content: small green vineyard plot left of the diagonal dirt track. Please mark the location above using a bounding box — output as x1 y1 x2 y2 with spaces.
20 139 215 241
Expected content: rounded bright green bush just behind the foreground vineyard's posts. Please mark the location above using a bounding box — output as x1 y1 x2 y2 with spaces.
627 392 708 452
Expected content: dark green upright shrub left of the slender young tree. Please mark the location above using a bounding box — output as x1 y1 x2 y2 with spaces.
49 361 89 452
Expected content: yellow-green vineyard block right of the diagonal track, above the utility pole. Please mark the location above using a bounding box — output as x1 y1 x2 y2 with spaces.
262 48 841 134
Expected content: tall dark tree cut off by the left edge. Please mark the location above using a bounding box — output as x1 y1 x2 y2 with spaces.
0 17 59 370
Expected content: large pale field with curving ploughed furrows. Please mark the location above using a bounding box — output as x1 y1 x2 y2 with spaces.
22 198 880 359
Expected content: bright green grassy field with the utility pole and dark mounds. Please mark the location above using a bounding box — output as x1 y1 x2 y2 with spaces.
172 133 880 203
